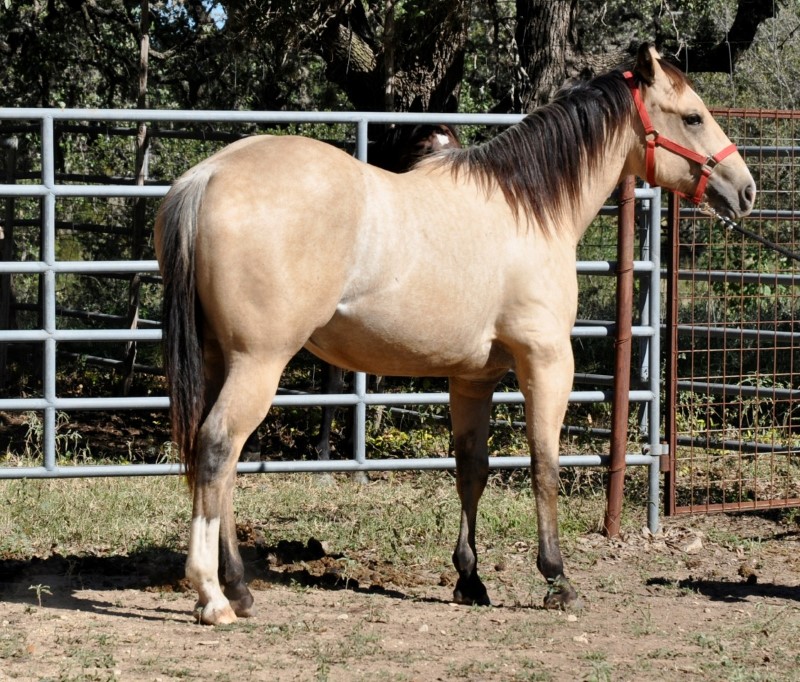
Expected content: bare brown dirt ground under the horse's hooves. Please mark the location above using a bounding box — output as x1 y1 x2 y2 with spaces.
0 515 800 681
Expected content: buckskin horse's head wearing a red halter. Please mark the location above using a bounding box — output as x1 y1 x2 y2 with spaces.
626 44 756 218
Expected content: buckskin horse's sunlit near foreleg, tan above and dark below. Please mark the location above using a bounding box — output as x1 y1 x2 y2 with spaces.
517 343 579 609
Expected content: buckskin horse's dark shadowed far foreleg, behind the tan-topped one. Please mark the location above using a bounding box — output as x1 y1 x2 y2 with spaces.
450 378 496 606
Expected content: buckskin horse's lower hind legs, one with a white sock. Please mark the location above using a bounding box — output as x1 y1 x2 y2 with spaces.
186 355 285 625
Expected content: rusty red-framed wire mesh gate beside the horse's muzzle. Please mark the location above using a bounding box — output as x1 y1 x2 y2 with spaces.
666 110 800 514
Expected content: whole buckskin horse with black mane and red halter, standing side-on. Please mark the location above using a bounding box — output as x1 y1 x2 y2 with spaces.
155 45 756 624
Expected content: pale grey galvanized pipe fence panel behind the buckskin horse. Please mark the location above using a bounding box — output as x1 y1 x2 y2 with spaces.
0 108 661 529
